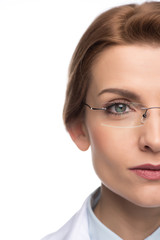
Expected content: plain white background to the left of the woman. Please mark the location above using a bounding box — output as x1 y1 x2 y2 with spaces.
0 0 152 240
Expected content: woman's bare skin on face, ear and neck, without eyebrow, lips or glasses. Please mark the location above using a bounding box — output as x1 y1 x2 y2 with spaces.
68 45 160 240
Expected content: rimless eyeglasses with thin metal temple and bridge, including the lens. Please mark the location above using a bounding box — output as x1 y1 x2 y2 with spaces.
84 102 160 128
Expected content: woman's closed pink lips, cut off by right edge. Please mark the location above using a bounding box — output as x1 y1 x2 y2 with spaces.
129 164 160 180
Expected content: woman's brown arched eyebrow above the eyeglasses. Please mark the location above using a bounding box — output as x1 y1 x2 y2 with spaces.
98 88 141 102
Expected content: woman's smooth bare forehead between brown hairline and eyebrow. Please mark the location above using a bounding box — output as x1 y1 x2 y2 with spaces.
89 45 160 100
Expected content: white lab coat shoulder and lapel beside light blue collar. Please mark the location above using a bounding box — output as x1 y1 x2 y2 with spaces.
42 196 90 240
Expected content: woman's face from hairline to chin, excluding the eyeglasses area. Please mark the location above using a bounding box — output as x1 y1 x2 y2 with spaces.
85 45 160 207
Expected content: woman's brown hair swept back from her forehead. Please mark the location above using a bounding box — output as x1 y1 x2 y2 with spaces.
63 2 160 126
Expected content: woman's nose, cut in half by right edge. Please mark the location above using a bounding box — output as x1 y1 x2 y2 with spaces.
139 109 160 153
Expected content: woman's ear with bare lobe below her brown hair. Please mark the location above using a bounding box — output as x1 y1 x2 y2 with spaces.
67 119 90 151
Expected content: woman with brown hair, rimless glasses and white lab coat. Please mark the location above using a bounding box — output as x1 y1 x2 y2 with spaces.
44 2 160 240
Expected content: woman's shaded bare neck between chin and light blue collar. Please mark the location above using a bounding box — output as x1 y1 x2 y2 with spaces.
94 185 160 240
